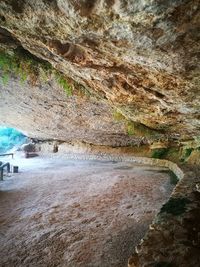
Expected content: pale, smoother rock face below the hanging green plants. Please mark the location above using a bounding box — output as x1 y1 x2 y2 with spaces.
0 73 139 146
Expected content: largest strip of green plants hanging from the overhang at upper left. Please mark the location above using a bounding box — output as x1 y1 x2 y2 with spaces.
0 48 73 96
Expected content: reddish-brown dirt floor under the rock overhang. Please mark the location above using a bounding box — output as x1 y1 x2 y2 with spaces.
0 154 173 267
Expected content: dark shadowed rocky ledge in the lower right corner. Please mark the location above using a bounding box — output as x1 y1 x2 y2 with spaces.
128 166 200 267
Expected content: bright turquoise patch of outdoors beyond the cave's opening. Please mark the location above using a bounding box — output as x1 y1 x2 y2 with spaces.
0 126 27 153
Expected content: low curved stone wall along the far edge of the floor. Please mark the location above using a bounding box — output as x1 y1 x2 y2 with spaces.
36 141 184 180
